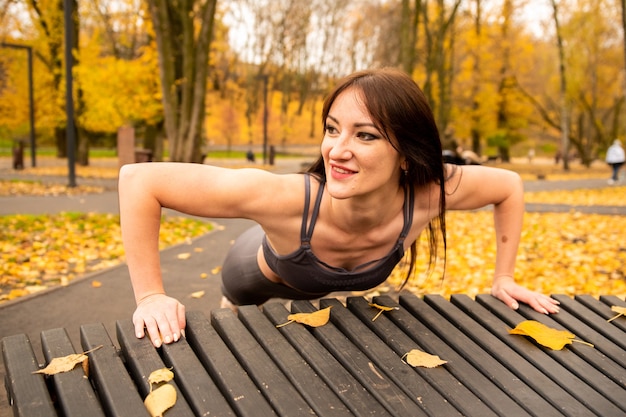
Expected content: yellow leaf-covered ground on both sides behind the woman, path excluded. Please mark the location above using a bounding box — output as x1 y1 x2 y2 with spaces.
0 164 626 302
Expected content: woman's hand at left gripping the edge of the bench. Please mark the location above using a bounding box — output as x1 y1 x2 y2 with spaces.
133 293 185 348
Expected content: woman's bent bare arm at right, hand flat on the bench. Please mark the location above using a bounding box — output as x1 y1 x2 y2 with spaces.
446 166 559 314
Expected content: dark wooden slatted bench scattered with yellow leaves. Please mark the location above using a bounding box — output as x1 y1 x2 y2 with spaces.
2 294 626 417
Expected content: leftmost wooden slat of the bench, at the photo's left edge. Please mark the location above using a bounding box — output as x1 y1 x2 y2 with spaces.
2 334 57 417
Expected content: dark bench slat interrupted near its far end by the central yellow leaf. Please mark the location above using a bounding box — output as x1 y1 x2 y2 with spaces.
291 300 426 416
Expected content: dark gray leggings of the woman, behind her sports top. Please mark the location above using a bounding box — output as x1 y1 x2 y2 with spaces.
222 225 326 305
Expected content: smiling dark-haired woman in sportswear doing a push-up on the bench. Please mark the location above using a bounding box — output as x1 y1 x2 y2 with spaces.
119 69 558 347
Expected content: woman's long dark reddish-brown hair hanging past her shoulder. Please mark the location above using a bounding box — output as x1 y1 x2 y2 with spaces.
307 68 447 287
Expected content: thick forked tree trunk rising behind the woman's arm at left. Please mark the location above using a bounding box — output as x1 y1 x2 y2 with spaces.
148 0 217 162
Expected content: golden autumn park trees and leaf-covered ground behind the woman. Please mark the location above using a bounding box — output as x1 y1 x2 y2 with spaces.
0 0 626 300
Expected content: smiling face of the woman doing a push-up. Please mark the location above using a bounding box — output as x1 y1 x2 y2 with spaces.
321 88 403 198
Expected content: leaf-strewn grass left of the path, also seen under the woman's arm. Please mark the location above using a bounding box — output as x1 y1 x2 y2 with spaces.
0 213 211 302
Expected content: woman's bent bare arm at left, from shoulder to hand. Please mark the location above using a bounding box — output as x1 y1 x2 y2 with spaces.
118 162 303 347
